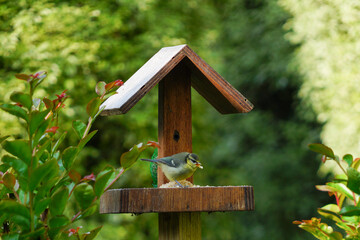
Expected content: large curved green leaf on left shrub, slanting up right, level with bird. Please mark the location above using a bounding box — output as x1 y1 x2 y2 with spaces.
29 159 59 191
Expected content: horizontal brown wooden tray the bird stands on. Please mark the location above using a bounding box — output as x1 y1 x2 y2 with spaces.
100 186 255 214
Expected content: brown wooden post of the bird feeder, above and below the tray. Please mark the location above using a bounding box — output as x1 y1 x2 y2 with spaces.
158 63 201 240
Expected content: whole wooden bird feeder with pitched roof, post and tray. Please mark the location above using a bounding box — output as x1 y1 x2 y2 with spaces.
100 45 255 240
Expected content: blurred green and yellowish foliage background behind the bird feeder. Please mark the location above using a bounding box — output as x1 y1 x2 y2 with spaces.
0 0 360 240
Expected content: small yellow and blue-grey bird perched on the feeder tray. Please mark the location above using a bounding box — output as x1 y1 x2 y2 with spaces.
141 152 203 187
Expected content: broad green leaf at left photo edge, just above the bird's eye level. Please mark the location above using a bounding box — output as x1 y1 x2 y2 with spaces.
3 140 31 166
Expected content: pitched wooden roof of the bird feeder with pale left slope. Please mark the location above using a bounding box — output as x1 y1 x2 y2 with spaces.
102 45 253 115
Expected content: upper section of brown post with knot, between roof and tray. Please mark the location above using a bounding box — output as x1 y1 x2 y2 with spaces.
158 63 192 186
